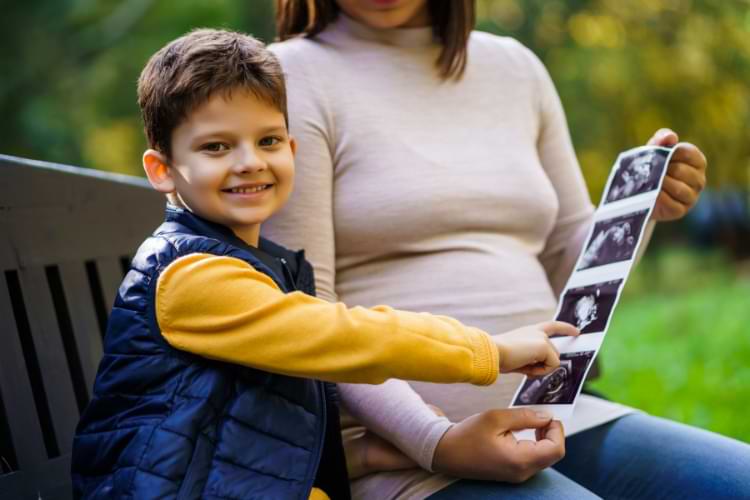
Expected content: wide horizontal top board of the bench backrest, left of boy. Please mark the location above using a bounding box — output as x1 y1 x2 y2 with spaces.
0 155 165 272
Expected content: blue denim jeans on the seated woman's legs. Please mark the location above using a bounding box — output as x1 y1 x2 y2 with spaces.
430 413 750 500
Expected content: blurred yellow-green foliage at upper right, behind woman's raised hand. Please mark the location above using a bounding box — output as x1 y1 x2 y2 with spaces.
479 0 750 200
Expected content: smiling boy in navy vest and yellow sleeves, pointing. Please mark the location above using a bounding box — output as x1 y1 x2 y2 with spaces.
72 30 576 499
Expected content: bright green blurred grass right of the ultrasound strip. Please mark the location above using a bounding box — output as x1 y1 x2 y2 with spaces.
591 250 750 442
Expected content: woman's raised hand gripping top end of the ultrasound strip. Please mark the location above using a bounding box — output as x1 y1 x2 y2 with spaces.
648 128 707 221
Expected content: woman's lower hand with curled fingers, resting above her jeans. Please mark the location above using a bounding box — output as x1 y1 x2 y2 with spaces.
432 408 565 483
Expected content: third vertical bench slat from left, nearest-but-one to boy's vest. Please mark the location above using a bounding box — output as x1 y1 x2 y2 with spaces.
60 262 102 397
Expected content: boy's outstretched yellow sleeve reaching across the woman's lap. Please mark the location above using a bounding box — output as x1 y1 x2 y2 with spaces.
156 254 499 385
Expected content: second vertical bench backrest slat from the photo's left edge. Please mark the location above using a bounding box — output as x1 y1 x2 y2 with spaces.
19 267 79 454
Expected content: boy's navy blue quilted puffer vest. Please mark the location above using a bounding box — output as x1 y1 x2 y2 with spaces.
72 207 349 499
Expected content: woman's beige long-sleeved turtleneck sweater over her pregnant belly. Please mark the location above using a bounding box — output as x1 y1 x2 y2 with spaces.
263 16 628 498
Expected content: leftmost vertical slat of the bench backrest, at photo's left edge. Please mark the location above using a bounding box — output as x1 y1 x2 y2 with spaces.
0 273 47 469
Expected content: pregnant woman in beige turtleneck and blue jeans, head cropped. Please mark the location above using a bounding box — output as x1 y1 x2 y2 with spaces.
264 0 750 499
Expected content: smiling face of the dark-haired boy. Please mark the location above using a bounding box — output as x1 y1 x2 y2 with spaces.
152 90 295 245
